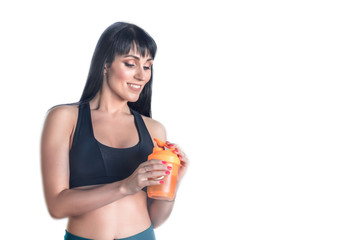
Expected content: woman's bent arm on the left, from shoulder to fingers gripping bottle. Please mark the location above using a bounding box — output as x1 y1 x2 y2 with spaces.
41 106 165 218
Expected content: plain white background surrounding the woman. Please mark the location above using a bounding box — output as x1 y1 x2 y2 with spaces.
0 0 360 240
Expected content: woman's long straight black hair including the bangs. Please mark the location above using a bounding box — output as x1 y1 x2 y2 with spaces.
80 22 157 117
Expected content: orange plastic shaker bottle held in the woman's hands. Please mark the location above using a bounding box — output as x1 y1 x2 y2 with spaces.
147 138 180 200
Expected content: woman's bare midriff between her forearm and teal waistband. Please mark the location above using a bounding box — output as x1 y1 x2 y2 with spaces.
67 185 151 240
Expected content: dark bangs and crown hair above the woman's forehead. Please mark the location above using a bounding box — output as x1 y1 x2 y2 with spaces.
114 26 157 59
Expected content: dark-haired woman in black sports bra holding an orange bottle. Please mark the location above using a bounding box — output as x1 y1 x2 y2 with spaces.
41 22 188 240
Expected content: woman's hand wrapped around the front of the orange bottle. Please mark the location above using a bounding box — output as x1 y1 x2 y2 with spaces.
123 159 170 195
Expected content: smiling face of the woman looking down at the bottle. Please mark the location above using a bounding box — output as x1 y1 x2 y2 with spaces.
104 50 153 102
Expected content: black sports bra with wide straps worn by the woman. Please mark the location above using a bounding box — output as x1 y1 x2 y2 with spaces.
69 103 154 188
